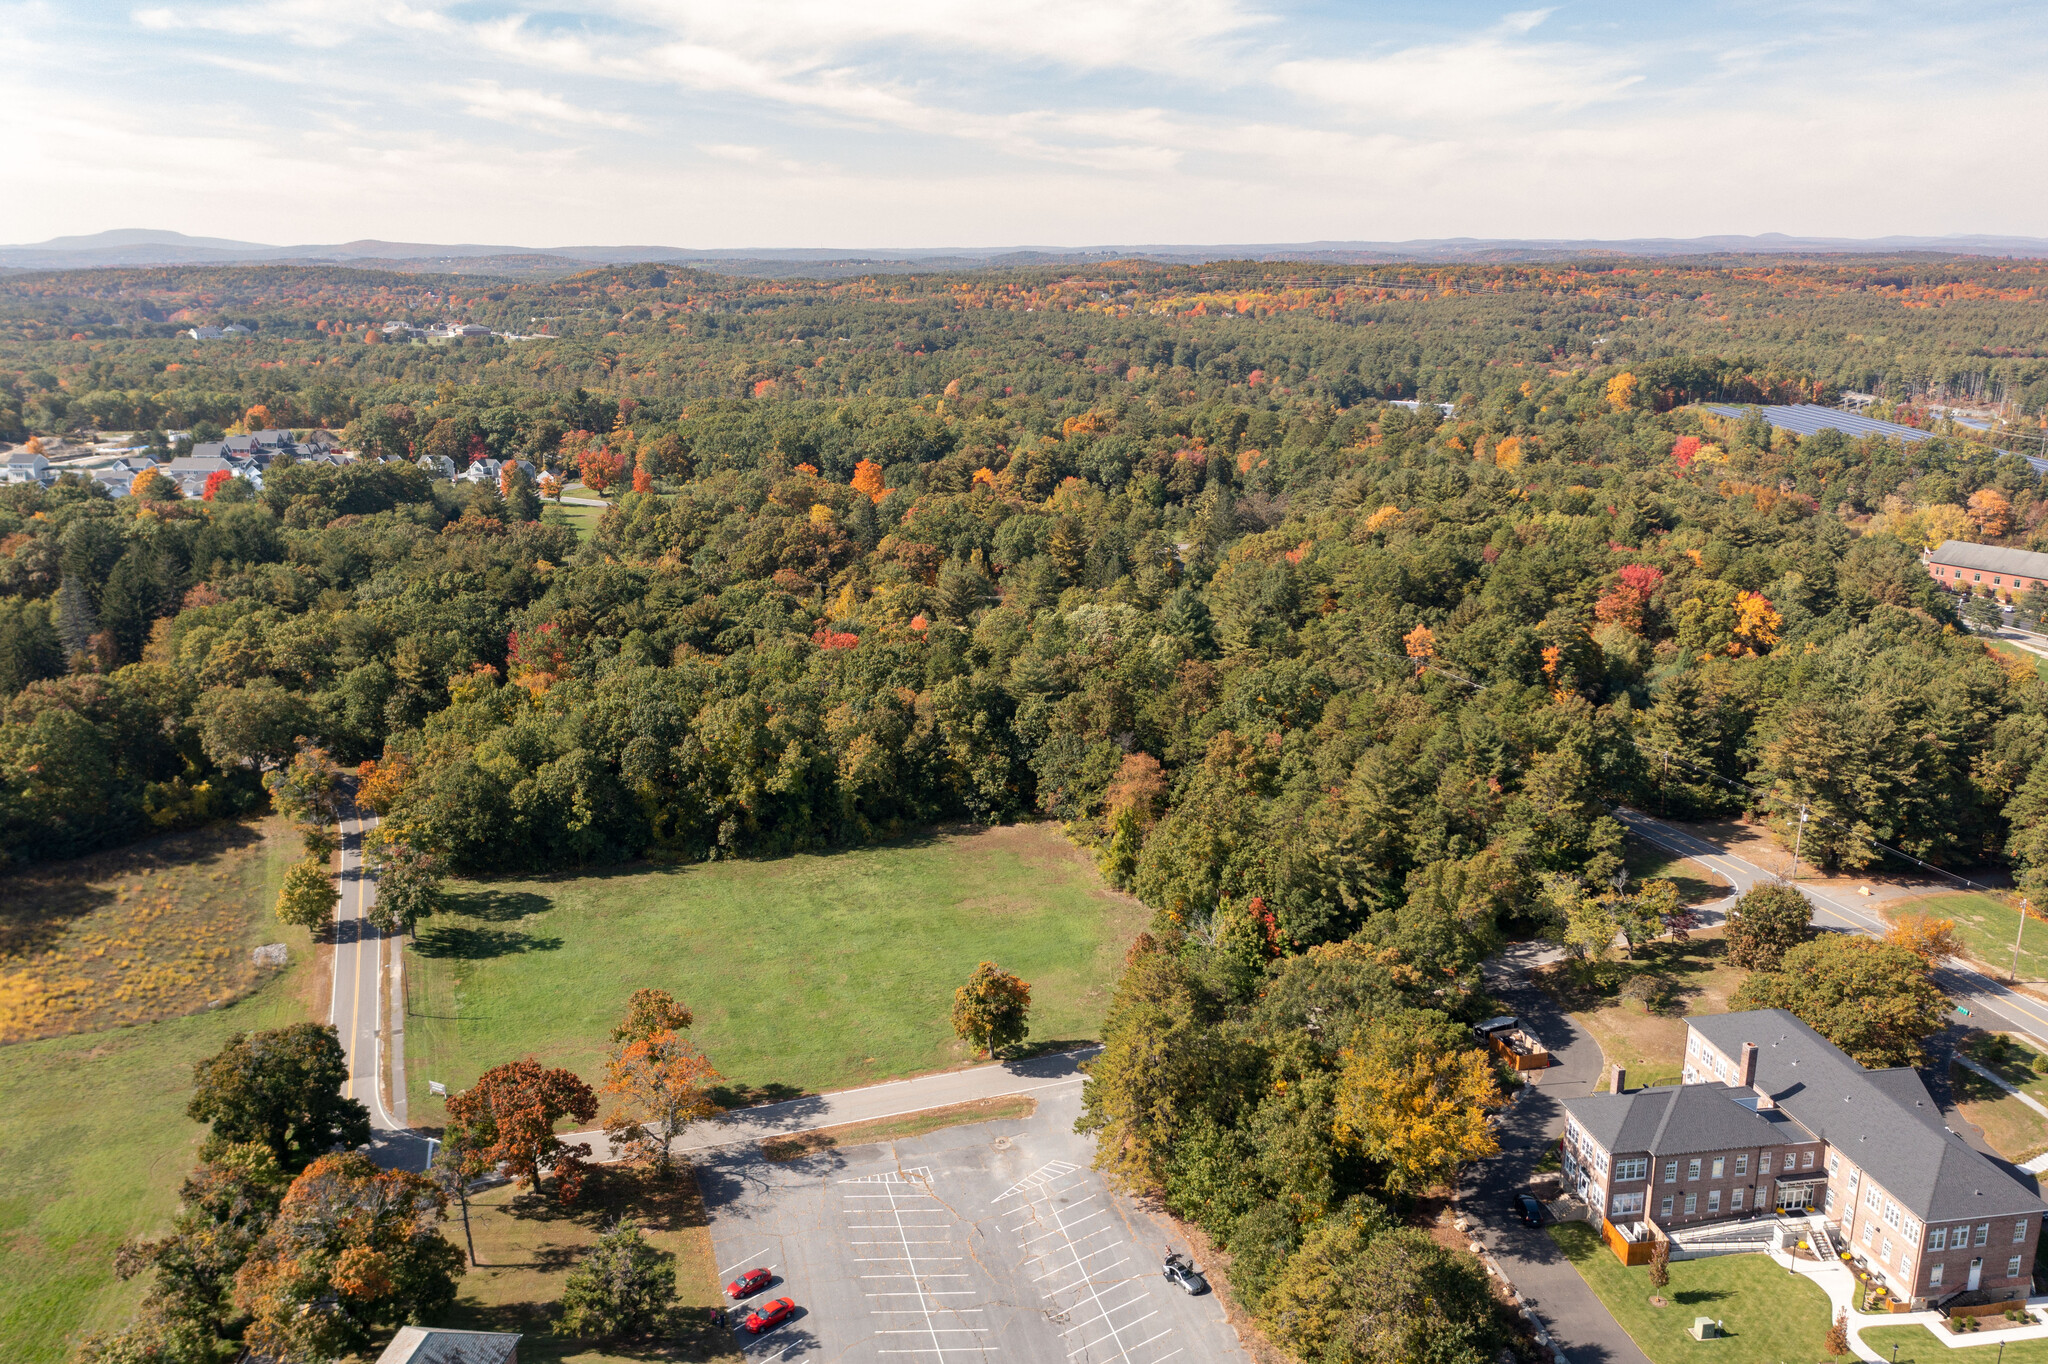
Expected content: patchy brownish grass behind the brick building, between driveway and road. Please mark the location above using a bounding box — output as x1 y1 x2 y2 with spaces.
1542 930 1749 1088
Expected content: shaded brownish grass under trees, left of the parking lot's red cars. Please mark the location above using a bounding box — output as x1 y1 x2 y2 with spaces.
434 1167 741 1364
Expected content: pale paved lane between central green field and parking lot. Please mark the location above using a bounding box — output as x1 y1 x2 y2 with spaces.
563 1045 1102 1161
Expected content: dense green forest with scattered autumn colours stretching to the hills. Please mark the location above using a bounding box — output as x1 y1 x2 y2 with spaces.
12 251 2048 1360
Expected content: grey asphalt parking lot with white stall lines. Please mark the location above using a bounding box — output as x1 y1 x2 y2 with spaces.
698 1081 1249 1364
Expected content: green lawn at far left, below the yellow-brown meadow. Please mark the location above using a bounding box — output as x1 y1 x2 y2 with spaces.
0 950 307 1364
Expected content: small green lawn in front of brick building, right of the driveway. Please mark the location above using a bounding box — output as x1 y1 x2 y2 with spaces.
1550 1223 1843 1364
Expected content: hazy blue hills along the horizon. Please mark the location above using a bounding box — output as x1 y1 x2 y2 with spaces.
0 227 2048 274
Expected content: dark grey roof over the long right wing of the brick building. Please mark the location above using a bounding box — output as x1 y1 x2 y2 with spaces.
1688 1010 2048 1223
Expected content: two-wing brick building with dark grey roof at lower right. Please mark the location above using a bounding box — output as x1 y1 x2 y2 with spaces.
1563 1010 2048 1307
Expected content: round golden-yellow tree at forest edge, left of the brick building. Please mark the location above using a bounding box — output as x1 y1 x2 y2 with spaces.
1335 1014 1501 1194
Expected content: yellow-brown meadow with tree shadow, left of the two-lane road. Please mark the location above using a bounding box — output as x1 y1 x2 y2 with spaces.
0 819 299 1042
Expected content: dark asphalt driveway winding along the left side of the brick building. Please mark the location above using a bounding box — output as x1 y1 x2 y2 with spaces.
1460 946 1649 1364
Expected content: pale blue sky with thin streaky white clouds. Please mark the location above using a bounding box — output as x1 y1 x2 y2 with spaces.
0 0 2048 250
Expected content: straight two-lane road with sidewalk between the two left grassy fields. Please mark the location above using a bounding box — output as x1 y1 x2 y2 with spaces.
330 811 428 1169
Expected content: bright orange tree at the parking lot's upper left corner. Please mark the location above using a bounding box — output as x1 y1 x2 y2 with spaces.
604 989 723 1176
